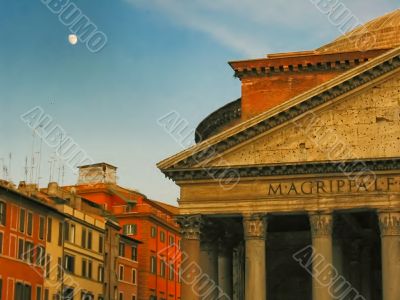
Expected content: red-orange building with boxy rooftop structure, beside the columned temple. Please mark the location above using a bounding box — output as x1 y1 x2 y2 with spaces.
69 163 180 300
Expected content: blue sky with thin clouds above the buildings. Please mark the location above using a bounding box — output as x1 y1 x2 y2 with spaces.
0 0 400 203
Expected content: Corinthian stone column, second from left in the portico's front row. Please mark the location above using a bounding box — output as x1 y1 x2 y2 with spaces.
243 215 267 300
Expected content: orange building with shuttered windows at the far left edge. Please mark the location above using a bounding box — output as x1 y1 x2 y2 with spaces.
0 182 58 300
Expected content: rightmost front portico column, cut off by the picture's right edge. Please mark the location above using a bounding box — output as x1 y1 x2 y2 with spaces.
378 212 400 300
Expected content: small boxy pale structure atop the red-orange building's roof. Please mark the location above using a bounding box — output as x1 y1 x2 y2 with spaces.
78 163 117 185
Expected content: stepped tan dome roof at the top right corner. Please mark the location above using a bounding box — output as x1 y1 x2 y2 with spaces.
317 9 400 52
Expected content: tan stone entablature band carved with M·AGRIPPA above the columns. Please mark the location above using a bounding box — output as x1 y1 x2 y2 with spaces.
179 170 400 215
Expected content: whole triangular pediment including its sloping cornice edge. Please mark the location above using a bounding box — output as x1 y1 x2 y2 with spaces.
158 48 400 174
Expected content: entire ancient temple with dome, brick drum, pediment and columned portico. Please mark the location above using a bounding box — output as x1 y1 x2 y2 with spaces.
158 10 400 300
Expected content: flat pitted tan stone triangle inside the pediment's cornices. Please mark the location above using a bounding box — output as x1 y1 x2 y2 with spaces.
203 74 400 167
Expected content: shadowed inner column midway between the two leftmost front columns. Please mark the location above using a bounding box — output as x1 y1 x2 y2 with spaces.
218 234 233 299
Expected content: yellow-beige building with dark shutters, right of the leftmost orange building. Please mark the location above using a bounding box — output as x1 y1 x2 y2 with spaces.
42 183 106 300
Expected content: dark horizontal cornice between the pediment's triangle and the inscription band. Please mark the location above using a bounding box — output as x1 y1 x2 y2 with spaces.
164 157 400 181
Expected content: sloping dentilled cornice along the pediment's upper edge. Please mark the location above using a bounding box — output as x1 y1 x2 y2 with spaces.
157 48 400 173
